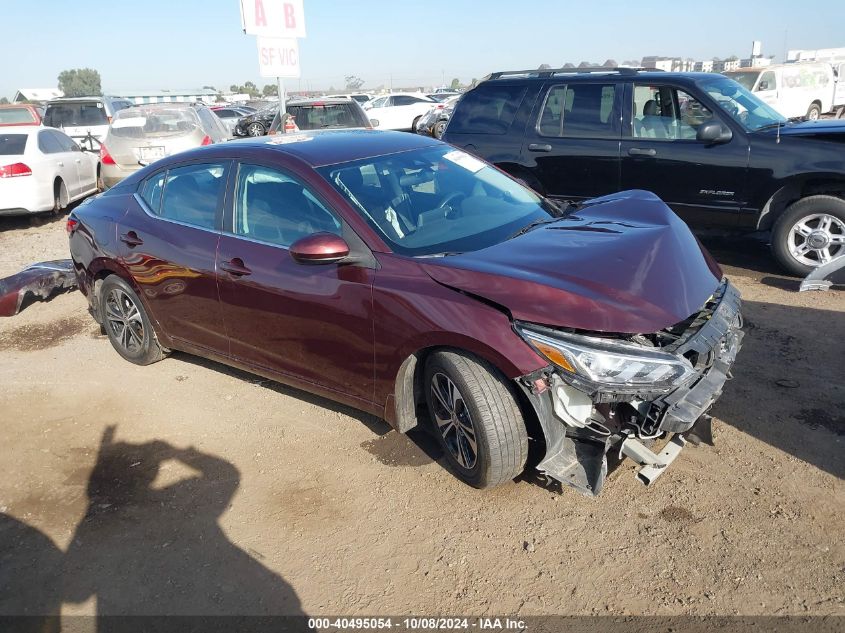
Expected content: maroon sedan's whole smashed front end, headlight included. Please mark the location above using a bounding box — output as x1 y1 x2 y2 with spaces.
514 280 743 495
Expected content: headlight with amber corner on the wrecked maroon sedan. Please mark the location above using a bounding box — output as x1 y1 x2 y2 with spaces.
516 325 695 394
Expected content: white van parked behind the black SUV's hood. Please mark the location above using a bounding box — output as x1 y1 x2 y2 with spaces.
724 62 836 121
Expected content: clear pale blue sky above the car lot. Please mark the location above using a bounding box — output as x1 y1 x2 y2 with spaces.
0 0 845 99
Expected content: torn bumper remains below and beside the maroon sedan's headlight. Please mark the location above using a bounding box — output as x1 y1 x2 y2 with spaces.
518 281 743 495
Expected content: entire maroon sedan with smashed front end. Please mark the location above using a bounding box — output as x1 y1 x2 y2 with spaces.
68 130 742 494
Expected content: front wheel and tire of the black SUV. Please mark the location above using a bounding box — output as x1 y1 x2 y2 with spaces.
772 196 845 276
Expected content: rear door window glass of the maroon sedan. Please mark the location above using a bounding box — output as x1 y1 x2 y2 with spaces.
161 164 226 229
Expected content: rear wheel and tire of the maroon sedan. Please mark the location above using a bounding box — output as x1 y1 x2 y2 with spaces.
100 275 165 365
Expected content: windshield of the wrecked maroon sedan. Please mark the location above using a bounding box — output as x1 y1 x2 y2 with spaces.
318 146 558 257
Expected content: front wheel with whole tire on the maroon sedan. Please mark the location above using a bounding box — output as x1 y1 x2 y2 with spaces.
424 351 528 488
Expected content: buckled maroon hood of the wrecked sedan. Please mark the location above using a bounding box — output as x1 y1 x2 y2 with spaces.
421 191 722 334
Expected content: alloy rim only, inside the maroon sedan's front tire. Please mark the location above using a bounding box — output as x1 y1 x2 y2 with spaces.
431 373 478 470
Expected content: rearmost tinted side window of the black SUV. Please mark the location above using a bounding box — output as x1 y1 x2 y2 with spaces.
449 82 528 134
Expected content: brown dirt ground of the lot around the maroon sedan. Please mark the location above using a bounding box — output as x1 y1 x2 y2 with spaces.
0 209 845 616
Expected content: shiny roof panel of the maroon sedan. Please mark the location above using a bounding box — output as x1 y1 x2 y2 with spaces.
168 128 446 167
